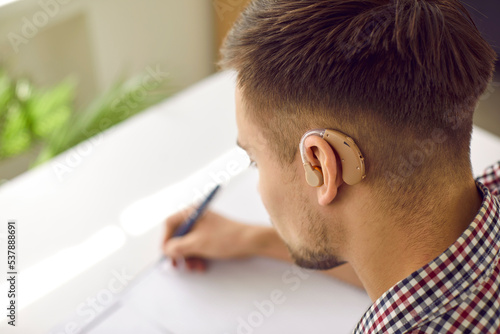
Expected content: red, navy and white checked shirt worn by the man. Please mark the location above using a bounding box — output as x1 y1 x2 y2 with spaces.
354 161 500 334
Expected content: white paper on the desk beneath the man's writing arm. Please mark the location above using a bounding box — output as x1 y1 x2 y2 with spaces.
81 170 371 334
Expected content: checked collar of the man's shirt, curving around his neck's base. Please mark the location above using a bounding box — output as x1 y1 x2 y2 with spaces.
354 181 500 333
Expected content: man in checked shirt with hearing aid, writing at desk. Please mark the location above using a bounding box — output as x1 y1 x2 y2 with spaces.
164 0 500 333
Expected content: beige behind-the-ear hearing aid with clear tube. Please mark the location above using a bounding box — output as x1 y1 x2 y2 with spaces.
299 129 366 187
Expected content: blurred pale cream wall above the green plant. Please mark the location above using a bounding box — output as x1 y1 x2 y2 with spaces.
0 0 215 105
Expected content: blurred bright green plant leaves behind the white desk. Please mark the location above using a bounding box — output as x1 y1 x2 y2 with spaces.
0 70 170 165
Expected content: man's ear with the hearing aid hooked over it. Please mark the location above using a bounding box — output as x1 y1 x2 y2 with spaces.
304 136 344 206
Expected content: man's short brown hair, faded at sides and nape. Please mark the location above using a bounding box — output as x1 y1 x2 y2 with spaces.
220 0 496 205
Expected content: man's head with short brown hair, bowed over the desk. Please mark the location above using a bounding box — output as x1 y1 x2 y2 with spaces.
222 0 495 268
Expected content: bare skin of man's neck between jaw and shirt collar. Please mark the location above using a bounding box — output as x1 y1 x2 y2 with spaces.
348 179 482 301
